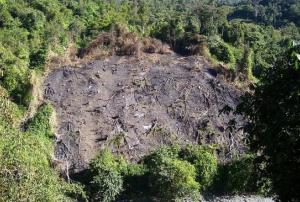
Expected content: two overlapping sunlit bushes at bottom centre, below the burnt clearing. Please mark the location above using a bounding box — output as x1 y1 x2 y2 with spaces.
145 145 217 199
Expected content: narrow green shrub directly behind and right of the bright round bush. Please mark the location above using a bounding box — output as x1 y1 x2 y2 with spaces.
180 145 217 189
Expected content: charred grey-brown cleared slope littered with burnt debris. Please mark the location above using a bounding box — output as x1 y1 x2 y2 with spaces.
44 54 244 172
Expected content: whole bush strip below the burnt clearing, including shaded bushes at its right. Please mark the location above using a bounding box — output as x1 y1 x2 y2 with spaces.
78 145 267 201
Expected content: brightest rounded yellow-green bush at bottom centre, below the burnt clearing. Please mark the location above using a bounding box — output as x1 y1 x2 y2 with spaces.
147 156 200 200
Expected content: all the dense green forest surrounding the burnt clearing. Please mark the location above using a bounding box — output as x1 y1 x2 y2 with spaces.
0 0 300 201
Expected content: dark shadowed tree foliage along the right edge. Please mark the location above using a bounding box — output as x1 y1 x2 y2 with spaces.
239 46 300 201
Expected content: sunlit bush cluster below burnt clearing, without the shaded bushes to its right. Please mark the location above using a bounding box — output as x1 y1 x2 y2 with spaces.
89 146 217 201
